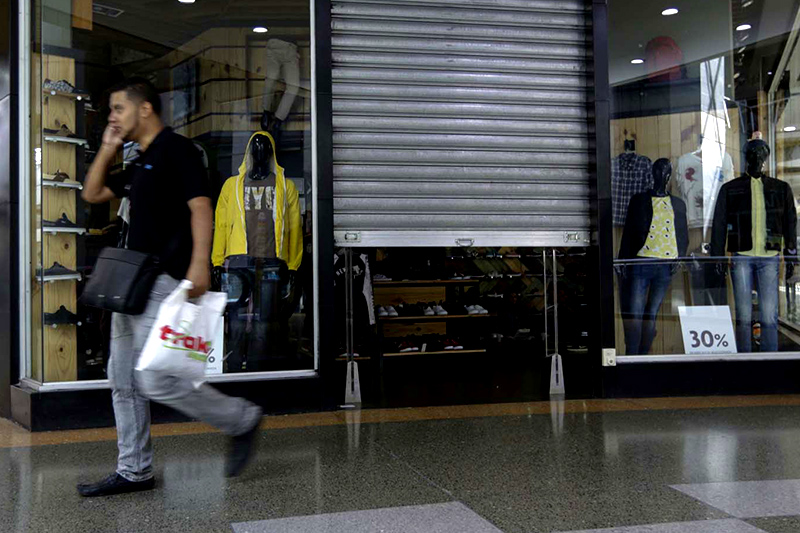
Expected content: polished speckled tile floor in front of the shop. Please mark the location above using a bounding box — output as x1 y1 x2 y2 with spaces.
0 396 800 533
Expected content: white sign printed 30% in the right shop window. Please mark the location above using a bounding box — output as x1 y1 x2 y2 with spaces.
678 305 736 354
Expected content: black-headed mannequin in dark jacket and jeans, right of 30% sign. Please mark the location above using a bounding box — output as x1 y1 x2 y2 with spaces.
711 139 797 353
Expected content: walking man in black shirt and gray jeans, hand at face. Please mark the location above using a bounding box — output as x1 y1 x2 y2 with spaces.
78 78 261 496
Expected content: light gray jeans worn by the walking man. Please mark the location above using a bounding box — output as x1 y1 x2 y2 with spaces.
108 274 261 481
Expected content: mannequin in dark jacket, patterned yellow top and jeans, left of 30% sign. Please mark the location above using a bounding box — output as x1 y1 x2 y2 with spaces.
619 158 689 355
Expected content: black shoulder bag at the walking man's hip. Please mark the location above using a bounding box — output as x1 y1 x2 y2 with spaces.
80 247 161 315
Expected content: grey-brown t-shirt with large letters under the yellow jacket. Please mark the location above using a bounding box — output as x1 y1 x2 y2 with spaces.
244 175 276 258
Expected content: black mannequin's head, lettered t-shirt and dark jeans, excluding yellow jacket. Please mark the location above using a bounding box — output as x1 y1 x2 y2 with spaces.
225 135 288 372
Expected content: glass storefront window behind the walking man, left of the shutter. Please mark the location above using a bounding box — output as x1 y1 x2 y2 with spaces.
26 0 316 383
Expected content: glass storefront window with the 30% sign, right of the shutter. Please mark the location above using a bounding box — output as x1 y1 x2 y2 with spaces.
609 0 800 356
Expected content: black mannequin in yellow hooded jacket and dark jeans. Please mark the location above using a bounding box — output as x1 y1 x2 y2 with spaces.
212 132 303 372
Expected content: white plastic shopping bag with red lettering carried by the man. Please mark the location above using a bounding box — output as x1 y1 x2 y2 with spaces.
136 280 227 387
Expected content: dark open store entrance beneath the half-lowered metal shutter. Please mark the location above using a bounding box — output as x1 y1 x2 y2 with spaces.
336 247 592 407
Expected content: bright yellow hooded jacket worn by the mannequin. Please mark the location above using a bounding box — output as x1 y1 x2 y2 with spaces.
211 131 303 270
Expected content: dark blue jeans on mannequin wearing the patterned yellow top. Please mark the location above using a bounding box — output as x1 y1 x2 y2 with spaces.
620 263 672 355
